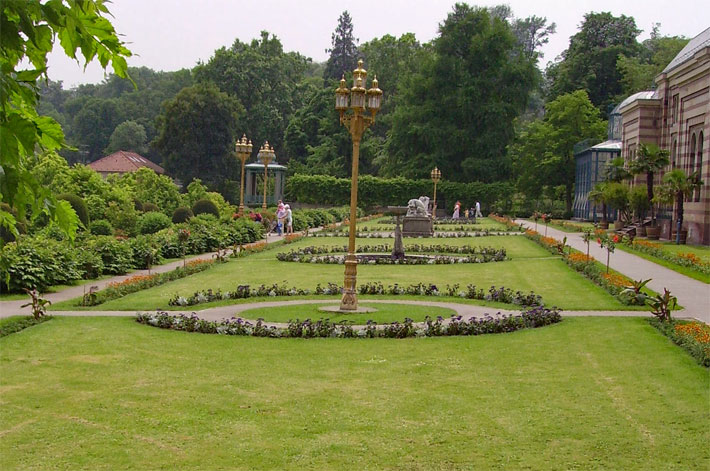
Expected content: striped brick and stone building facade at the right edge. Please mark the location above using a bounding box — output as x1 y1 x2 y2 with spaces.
619 28 710 245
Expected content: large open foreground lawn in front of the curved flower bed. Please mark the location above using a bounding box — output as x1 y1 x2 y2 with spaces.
0 318 710 471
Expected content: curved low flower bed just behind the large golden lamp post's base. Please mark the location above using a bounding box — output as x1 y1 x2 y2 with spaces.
168 282 543 306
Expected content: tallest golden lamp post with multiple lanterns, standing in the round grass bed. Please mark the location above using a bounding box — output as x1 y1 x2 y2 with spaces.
335 59 382 311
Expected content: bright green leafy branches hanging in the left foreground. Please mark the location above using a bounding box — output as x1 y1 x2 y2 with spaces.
0 0 131 242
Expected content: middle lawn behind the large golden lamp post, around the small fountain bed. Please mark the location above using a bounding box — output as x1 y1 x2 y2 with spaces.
51 236 645 310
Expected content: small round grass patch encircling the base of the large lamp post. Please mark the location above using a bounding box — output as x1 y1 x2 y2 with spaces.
240 301 456 324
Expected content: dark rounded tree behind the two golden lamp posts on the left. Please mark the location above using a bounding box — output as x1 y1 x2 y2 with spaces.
154 84 244 185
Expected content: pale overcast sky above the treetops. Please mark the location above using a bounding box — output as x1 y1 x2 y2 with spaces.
49 0 710 88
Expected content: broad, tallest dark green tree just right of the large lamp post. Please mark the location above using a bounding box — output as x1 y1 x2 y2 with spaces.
383 4 536 182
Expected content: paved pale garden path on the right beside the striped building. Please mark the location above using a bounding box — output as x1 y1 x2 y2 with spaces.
515 219 710 324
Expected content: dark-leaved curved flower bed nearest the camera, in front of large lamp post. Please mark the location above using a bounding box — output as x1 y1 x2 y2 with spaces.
136 307 562 338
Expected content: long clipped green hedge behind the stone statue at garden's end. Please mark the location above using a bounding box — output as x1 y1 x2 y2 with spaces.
286 174 515 210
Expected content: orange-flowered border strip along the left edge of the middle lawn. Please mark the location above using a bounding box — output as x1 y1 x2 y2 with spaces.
79 259 215 306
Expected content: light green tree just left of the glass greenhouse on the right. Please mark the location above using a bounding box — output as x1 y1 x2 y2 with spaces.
511 90 606 214
